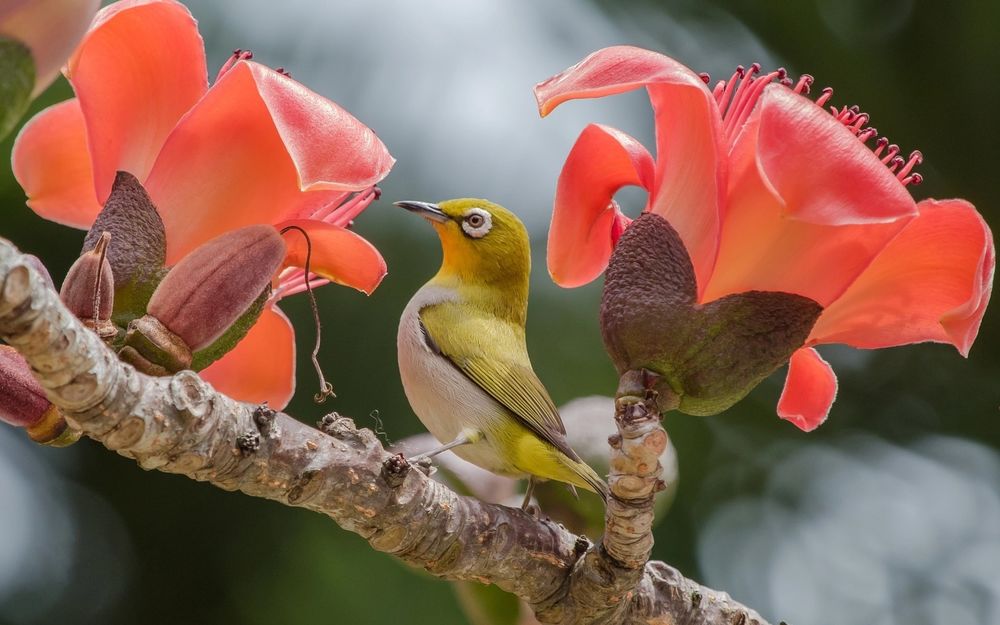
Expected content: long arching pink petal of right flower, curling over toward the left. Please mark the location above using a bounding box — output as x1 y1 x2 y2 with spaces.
535 46 725 289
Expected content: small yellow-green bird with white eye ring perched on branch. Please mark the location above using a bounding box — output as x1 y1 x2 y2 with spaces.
396 199 608 509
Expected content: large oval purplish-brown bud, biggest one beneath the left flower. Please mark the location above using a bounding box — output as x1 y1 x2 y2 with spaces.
121 225 285 375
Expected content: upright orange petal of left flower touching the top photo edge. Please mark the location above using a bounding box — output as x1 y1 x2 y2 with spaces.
66 0 208 202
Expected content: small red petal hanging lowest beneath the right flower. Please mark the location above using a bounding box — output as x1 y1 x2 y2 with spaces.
778 347 837 432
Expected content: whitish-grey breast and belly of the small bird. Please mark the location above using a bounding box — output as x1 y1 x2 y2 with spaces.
396 286 519 475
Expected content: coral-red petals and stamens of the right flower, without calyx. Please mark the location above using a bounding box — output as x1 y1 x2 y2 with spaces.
535 46 995 430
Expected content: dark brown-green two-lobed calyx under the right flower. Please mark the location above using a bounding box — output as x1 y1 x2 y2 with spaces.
601 213 823 415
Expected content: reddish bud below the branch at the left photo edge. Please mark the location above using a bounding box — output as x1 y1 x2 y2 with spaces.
0 345 79 447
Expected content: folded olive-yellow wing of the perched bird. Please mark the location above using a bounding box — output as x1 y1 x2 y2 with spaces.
420 302 578 460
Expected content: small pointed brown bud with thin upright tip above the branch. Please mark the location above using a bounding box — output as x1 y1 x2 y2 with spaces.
59 232 118 338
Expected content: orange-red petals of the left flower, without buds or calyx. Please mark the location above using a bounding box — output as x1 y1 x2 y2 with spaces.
13 0 394 407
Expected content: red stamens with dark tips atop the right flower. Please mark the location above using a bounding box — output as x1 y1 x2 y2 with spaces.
699 63 923 186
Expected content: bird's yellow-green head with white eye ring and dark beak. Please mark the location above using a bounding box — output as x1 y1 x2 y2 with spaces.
396 198 531 316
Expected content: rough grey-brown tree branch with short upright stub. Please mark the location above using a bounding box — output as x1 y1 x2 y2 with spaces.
0 239 767 625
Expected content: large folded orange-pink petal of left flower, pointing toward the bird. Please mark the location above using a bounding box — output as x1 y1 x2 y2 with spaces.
146 62 393 263
